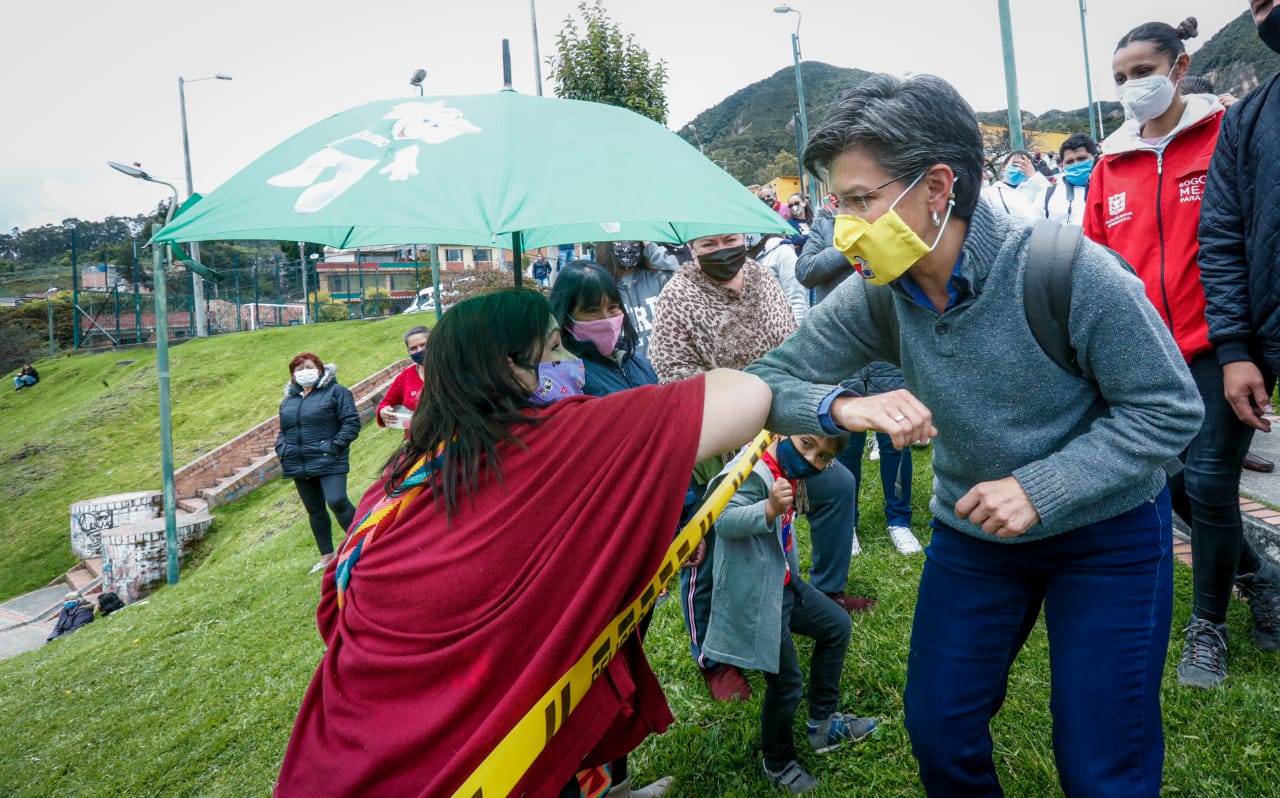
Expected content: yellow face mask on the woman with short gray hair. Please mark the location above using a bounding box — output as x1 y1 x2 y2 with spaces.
832 172 955 286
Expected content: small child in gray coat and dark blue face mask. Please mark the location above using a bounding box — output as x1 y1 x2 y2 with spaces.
703 434 876 794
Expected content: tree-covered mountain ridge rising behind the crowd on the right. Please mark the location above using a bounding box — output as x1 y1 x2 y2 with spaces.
678 12 1280 184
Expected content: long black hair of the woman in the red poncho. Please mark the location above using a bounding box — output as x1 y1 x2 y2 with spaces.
385 288 552 519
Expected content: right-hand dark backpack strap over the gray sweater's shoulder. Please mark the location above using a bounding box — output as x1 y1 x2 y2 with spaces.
1023 219 1084 375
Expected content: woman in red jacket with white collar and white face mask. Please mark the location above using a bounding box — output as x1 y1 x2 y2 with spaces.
1084 18 1274 688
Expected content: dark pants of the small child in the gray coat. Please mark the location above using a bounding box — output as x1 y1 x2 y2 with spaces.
760 579 852 771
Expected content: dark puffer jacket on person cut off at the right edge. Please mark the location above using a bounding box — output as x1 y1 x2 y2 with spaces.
1199 74 1280 373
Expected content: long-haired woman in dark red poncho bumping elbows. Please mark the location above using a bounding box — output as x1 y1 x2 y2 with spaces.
275 291 769 798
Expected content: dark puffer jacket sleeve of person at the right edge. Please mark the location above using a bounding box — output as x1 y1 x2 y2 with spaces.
1199 98 1252 365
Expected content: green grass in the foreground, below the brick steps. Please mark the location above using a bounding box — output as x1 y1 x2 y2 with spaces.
0 430 1280 798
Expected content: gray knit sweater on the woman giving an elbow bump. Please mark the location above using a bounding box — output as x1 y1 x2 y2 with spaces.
748 202 1204 542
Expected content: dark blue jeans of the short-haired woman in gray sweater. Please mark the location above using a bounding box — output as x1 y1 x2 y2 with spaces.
902 491 1174 798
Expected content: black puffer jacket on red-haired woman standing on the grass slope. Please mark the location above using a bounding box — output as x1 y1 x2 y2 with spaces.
275 366 360 479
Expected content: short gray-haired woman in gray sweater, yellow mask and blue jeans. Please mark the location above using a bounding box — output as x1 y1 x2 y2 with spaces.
749 74 1203 797
